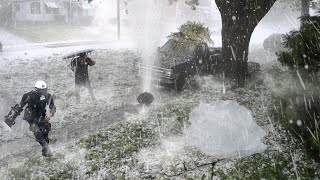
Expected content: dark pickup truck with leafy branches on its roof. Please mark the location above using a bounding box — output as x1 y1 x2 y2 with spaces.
133 39 259 91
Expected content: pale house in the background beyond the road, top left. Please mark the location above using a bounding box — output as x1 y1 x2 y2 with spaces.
11 0 94 24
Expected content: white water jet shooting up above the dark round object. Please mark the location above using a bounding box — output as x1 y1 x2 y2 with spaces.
129 0 172 91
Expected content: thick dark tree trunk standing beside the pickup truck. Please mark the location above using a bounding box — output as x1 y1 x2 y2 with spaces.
215 0 276 87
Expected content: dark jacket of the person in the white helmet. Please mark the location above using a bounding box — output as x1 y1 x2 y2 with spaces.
15 91 56 122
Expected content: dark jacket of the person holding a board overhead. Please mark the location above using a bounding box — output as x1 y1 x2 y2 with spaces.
71 57 95 85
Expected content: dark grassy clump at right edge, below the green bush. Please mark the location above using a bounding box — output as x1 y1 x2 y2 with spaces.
270 71 320 163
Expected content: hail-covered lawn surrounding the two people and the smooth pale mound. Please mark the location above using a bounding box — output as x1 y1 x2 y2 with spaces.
0 47 319 179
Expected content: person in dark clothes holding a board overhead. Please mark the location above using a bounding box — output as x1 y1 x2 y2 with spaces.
70 53 96 103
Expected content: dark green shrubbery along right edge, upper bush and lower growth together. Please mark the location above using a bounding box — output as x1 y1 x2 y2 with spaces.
273 13 320 162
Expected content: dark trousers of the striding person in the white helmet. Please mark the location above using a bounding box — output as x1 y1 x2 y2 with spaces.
28 118 51 146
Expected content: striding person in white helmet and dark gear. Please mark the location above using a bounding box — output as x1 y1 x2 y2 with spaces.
8 81 56 156
